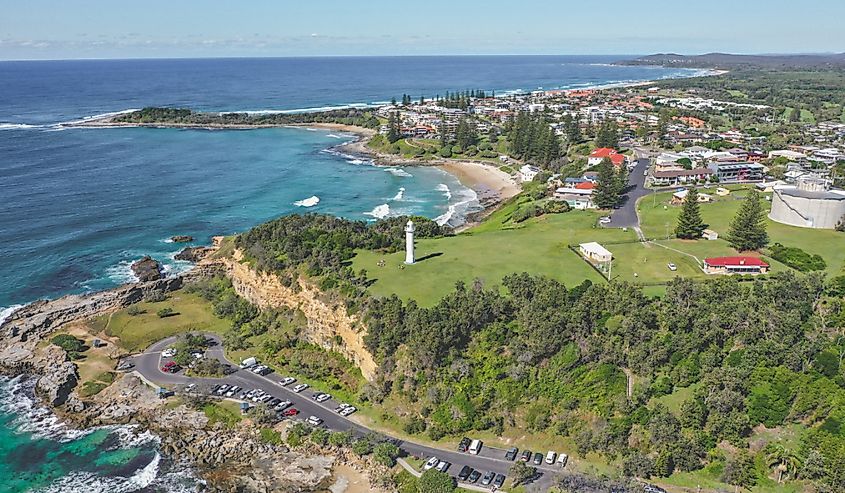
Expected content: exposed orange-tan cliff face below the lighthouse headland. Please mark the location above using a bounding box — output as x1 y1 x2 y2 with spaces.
221 251 378 381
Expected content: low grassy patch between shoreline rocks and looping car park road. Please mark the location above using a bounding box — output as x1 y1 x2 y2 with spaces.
90 291 231 352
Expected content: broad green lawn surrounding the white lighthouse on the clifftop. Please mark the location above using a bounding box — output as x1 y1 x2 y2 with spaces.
346 209 636 306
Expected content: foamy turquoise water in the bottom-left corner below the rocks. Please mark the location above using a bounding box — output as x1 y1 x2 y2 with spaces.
0 377 201 493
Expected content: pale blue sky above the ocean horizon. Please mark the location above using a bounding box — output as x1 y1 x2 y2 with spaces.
0 0 845 59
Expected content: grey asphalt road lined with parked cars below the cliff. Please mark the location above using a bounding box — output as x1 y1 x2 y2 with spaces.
126 334 562 491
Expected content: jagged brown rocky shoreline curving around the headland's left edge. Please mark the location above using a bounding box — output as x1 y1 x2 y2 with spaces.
0 260 380 493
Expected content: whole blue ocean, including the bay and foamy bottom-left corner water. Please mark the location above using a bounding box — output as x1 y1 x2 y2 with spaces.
0 56 696 491
